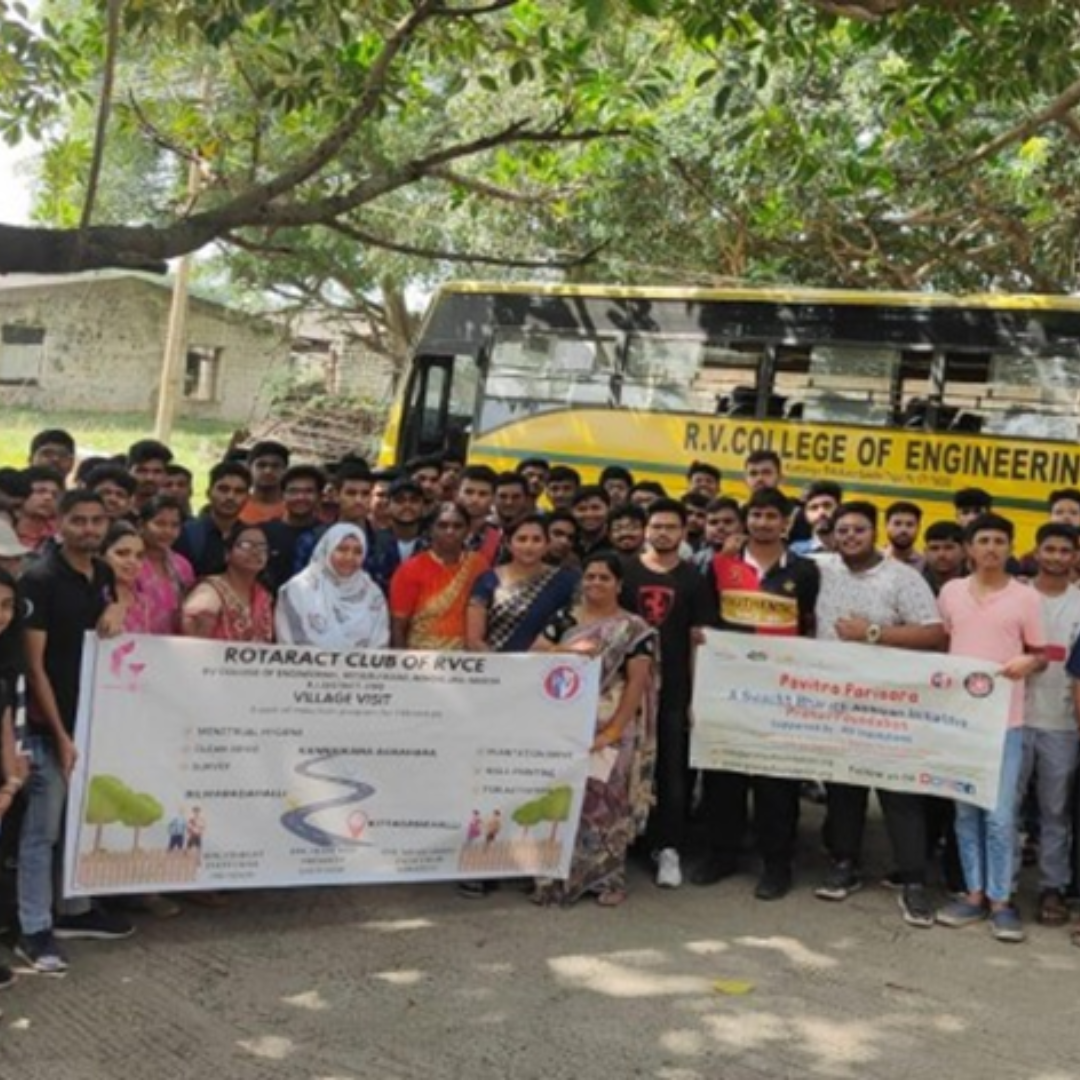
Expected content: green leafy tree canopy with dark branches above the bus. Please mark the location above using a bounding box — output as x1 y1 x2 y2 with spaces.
6 0 1080 293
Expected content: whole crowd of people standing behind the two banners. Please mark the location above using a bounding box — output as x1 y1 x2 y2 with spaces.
0 431 1080 997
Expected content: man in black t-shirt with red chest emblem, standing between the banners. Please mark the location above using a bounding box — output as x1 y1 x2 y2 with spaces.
621 499 710 889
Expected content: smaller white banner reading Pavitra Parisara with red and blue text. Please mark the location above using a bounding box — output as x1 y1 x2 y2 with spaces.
690 631 1012 808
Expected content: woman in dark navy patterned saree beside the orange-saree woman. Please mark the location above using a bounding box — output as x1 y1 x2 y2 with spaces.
465 514 581 652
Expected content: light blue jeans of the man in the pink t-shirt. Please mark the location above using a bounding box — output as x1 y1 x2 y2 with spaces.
956 728 1024 904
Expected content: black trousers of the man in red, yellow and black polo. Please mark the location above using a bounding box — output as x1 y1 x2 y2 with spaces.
702 770 799 868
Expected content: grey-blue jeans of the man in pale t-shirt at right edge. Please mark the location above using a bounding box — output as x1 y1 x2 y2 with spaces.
1016 728 1080 891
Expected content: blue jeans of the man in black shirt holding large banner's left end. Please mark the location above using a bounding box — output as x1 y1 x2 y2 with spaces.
17 735 91 934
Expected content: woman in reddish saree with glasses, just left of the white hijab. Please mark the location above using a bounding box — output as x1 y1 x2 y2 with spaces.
180 525 273 643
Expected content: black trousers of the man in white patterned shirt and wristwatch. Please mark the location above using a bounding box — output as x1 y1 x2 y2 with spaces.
825 784 927 885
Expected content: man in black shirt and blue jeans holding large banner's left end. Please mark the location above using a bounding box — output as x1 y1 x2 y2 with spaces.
16 490 132 974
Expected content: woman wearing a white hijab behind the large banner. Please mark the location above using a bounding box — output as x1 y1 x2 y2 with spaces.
275 524 390 652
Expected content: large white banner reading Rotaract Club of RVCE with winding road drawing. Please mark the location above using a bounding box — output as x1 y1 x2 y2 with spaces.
65 636 598 896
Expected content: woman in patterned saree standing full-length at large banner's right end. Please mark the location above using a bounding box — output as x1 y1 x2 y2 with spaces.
532 551 658 907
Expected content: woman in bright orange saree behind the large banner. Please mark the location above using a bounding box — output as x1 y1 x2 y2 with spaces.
390 502 487 651
